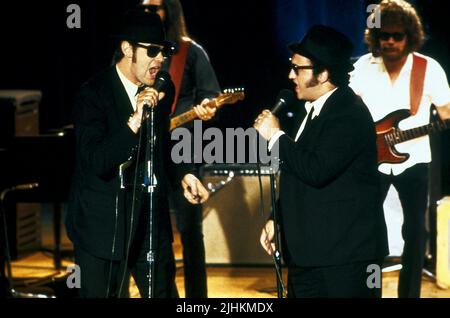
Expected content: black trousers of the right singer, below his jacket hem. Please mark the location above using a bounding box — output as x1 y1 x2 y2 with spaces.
288 260 382 298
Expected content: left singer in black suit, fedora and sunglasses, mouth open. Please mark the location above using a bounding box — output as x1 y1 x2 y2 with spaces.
66 10 208 298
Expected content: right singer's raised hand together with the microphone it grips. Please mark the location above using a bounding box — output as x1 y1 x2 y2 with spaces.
253 89 294 140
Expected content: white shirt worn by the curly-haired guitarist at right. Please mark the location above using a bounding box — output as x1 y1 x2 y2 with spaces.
350 53 450 175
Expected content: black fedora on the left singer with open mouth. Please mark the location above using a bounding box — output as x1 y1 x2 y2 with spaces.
113 8 166 45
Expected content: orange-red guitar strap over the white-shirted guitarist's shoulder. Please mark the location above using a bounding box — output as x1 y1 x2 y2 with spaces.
409 54 427 116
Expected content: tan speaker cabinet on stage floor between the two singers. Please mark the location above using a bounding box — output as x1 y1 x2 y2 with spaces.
203 175 272 265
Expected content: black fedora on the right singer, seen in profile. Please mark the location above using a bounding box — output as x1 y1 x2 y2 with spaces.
288 25 353 72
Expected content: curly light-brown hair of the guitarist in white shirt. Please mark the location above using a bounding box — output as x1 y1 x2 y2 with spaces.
364 0 425 56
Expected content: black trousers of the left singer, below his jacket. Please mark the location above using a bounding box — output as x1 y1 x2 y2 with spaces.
74 206 178 298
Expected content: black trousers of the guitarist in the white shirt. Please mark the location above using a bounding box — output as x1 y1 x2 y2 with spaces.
381 164 428 298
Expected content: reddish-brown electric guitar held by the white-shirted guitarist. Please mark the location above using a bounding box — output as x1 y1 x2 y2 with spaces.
375 109 450 164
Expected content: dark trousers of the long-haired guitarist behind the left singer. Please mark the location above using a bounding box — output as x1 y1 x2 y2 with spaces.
171 189 208 298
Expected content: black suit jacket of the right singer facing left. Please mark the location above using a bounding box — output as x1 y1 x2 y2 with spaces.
278 87 388 266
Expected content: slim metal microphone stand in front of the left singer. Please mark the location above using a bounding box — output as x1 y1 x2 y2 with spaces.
143 105 157 298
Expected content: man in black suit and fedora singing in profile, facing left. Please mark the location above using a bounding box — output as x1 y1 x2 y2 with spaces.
255 26 388 297
